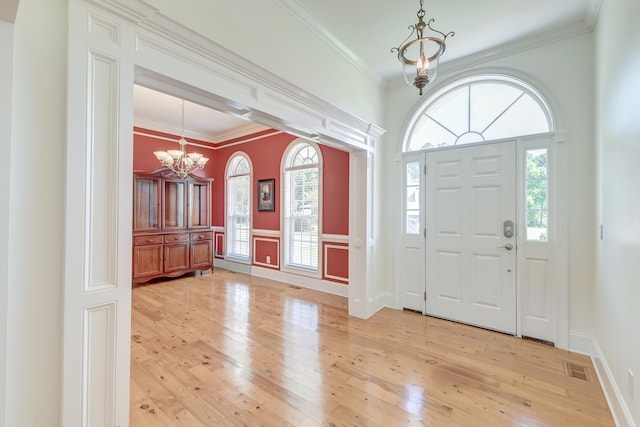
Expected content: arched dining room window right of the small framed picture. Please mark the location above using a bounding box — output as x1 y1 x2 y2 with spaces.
282 140 322 271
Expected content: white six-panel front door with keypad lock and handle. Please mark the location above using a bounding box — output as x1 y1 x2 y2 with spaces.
425 142 516 334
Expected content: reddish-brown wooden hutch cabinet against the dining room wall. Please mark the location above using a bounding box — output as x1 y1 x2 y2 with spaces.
132 169 213 283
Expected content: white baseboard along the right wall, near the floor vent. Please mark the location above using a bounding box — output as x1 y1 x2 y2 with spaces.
591 338 637 427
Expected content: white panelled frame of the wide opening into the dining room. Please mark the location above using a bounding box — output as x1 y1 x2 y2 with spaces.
61 0 384 426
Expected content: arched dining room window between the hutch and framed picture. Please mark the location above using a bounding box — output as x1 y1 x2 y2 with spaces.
226 153 251 261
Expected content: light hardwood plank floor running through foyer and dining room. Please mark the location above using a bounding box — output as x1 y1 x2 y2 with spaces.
130 269 614 427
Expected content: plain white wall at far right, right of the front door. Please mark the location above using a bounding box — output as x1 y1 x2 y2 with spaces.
594 0 640 423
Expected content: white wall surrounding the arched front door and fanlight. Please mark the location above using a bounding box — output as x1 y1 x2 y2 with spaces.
383 34 595 344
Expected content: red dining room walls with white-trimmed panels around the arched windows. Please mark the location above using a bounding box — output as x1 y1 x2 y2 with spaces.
133 128 349 284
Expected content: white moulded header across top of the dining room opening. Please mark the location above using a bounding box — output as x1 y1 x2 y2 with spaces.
90 0 385 150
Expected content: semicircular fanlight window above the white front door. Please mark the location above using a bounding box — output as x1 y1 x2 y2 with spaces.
403 75 554 152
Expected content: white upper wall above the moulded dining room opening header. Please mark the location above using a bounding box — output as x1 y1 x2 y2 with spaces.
142 0 386 124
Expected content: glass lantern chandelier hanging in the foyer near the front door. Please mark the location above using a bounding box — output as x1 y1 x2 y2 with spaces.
391 0 455 95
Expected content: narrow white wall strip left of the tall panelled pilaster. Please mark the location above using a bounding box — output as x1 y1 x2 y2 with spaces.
7 0 67 427
